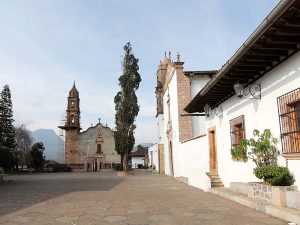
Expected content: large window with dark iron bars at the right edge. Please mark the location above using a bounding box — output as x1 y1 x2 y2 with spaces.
277 88 300 154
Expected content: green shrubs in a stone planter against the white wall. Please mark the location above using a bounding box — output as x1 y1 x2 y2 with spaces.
231 129 297 206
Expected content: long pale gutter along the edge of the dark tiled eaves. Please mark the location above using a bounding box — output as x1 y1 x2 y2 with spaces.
197 0 296 96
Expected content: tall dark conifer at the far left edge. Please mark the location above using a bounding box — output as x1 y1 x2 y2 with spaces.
0 85 16 171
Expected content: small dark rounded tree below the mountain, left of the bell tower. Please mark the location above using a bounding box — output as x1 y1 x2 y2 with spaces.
30 142 45 171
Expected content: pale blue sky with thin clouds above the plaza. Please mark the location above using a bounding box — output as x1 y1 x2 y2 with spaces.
0 0 279 143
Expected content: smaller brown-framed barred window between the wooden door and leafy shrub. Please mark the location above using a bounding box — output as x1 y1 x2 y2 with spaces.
229 116 245 148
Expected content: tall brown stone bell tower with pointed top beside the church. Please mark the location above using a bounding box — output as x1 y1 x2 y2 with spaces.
59 81 80 164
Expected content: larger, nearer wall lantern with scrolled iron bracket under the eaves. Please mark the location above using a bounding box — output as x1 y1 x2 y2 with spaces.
233 82 261 99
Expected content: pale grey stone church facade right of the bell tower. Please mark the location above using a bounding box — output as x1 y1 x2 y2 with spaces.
78 124 120 163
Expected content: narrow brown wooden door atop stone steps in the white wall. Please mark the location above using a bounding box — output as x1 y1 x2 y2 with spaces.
208 128 218 172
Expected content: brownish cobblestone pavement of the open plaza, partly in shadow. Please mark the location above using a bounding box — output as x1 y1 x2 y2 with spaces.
0 171 287 225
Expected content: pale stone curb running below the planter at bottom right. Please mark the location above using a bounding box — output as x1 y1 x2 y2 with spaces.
209 188 300 225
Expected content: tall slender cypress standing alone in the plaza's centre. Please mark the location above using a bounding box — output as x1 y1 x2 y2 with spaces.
114 42 142 171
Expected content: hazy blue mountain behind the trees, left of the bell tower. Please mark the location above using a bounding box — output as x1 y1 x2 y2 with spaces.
32 129 61 161
